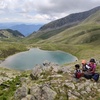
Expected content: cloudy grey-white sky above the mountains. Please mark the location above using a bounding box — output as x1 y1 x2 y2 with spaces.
0 0 100 24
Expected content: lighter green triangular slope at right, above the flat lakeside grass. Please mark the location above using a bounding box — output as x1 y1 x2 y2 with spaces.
45 11 100 44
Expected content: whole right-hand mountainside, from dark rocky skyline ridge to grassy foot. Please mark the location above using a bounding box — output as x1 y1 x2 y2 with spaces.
26 7 100 44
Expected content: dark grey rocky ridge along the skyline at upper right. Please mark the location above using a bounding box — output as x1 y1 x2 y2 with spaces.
39 6 100 31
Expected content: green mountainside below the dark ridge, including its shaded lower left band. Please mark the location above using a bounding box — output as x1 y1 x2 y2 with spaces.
26 10 100 44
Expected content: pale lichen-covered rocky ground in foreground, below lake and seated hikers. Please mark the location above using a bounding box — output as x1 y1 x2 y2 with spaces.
14 62 100 100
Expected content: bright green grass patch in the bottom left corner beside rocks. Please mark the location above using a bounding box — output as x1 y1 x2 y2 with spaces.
0 77 20 100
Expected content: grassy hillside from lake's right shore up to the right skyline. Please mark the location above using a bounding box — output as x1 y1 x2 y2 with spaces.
25 12 100 59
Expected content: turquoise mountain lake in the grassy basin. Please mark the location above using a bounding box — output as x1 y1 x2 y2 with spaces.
0 48 77 70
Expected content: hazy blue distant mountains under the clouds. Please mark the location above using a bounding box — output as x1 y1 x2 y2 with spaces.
0 23 42 36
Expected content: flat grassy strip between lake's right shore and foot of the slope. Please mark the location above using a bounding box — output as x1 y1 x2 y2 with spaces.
31 43 100 59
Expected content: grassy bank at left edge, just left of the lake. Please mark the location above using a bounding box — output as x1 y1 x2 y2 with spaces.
0 41 27 60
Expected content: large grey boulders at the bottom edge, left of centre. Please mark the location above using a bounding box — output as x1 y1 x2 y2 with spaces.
14 85 57 100
